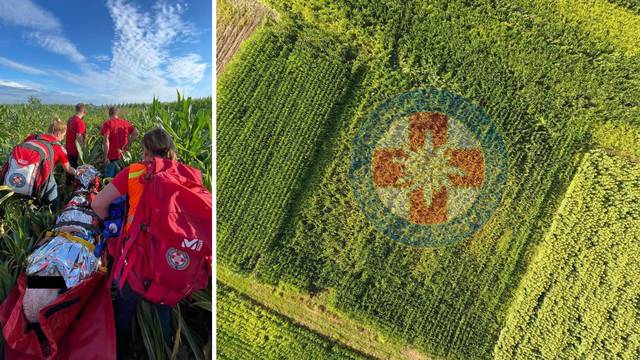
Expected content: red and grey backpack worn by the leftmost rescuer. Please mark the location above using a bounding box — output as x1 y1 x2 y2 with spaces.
0 134 60 198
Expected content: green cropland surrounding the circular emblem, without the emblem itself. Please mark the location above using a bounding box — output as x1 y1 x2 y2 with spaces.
217 0 640 359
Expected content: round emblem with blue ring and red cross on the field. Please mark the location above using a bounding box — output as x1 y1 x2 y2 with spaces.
349 89 507 247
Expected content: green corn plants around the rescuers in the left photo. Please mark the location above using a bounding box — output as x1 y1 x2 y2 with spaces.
0 94 212 359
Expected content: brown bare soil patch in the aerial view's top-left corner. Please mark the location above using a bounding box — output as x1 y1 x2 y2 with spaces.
216 0 276 74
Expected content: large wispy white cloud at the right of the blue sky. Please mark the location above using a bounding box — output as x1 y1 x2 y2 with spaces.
57 0 209 102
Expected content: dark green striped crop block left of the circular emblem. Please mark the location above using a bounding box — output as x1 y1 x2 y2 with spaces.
217 22 351 269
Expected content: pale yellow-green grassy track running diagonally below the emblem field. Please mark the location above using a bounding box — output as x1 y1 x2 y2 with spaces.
216 264 436 360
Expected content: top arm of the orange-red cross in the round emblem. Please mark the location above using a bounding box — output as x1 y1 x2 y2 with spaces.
409 112 447 151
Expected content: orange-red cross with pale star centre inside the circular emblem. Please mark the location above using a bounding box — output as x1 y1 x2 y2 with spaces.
371 112 485 224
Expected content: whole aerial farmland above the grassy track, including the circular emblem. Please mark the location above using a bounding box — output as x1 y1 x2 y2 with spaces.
216 0 640 359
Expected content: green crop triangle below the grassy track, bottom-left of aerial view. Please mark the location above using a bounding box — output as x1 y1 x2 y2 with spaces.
216 285 365 360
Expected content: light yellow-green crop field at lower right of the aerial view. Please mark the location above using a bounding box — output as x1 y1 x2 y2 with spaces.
495 150 640 359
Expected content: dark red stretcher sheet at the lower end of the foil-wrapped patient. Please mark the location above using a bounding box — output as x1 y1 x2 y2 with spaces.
0 272 116 360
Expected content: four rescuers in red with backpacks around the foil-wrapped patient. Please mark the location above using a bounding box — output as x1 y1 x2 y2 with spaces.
0 104 211 358
